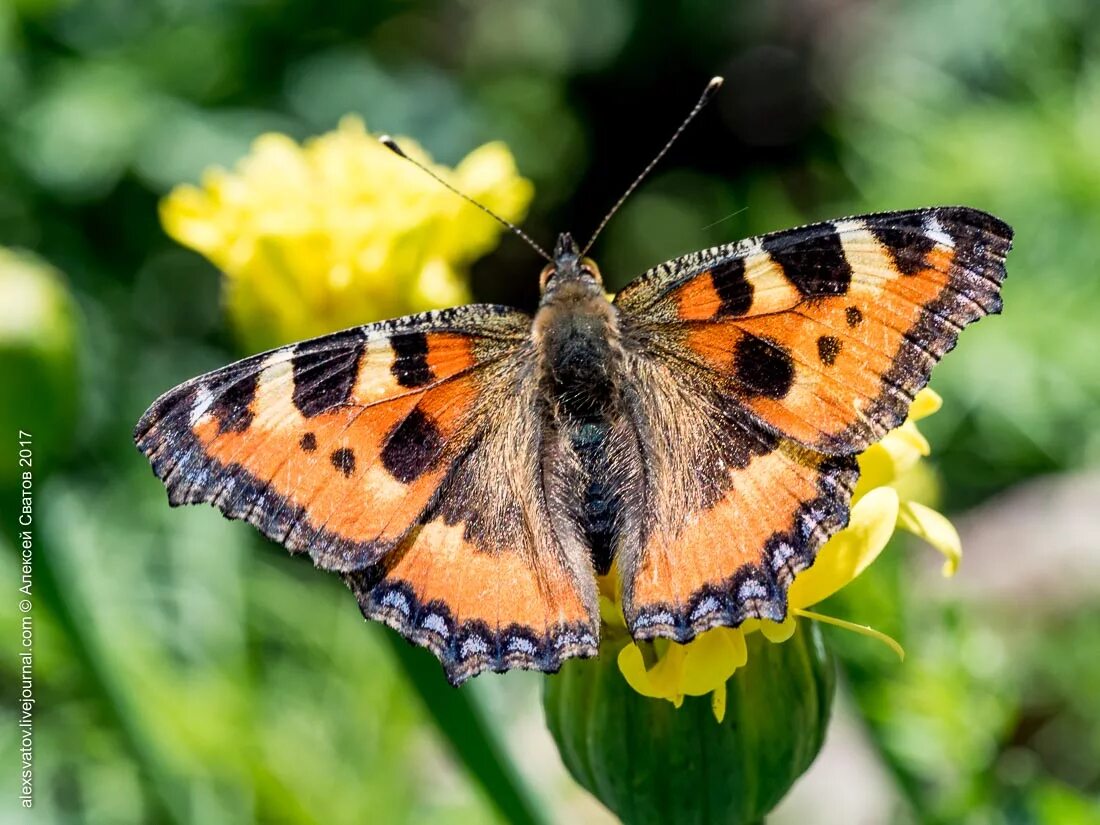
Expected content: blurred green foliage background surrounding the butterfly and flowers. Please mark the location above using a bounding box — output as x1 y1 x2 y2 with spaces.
0 0 1100 824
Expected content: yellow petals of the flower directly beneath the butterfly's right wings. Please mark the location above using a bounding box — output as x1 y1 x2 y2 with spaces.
616 389 963 722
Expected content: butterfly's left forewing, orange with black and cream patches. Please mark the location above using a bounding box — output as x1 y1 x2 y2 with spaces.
134 316 509 570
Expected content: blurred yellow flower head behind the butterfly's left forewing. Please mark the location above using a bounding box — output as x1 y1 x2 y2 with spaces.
161 117 534 349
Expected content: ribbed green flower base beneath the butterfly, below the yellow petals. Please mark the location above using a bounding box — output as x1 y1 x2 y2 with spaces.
543 620 835 825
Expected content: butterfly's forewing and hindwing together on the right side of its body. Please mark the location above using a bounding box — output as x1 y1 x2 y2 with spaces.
615 207 1012 640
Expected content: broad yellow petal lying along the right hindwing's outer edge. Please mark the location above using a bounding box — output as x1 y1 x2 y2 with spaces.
788 487 899 607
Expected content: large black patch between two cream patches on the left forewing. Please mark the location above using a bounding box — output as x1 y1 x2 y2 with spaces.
290 329 366 418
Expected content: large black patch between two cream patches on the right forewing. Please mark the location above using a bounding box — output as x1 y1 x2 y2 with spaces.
761 223 851 298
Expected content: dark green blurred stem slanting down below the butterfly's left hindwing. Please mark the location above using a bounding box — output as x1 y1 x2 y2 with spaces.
385 629 546 825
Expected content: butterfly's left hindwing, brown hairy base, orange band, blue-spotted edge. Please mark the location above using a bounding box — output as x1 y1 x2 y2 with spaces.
344 370 600 684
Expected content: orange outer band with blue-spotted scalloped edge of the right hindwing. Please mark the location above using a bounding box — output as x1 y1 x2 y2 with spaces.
623 441 859 641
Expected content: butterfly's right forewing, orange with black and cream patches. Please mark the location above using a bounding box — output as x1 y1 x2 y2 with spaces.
615 207 1012 454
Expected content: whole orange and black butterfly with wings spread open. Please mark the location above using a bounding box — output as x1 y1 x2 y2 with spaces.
134 84 1012 684
